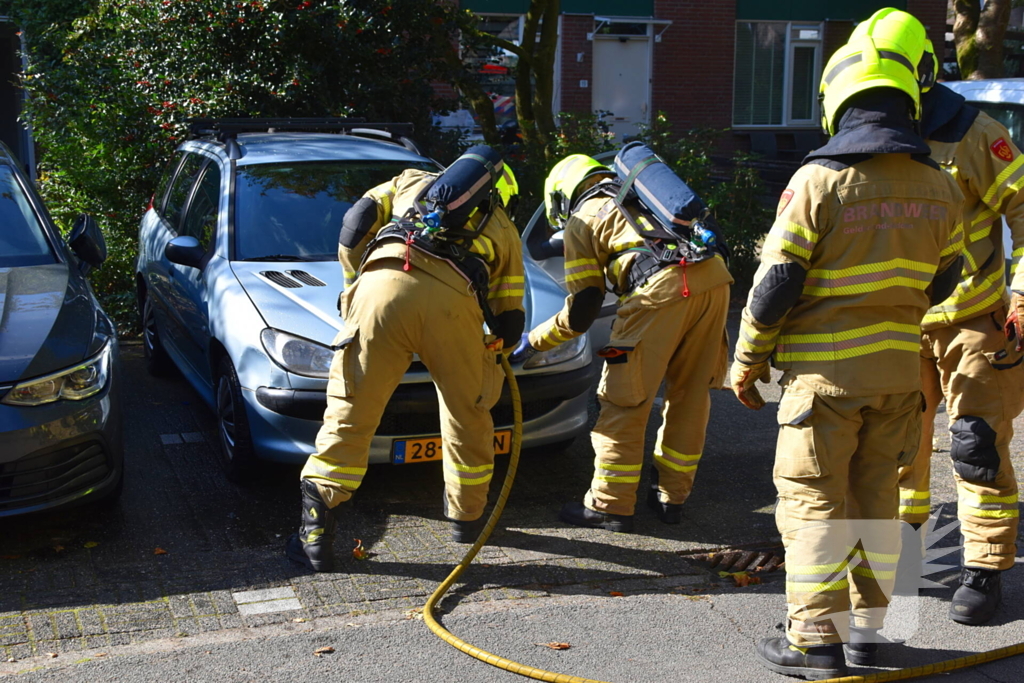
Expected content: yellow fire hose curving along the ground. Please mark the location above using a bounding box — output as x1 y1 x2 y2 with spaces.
423 354 1024 683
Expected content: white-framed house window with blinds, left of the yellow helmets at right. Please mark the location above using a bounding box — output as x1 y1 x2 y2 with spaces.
732 22 822 127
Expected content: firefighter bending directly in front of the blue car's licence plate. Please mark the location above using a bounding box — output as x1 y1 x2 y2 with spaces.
287 145 525 571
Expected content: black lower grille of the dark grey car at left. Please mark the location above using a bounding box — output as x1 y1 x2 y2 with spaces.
0 441 111 510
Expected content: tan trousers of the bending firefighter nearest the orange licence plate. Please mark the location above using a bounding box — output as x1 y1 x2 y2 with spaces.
302 259 504 521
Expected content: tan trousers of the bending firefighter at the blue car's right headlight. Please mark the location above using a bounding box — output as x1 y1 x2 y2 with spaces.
584 285 729 515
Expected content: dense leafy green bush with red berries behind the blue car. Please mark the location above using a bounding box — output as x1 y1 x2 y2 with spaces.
6 0 471 331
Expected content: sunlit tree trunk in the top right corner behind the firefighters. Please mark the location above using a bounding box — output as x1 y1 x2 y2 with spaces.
953 0 1011 80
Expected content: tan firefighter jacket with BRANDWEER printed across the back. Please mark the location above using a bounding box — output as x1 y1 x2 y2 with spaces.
735 154 963 396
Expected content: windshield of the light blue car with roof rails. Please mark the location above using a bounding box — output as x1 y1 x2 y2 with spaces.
234 161 437 261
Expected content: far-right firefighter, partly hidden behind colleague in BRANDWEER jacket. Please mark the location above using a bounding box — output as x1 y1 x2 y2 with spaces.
854 8 1024 625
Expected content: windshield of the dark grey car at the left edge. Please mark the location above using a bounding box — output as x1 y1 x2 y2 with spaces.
0 166 56 267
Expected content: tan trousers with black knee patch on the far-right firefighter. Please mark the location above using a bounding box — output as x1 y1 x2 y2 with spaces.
900 310 1024 570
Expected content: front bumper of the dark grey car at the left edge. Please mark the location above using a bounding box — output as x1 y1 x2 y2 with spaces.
0 382 124 517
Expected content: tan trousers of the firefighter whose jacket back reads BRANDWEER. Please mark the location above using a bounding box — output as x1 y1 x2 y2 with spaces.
773 376 922 646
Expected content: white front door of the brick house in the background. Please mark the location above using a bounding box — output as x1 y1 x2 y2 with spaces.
593 36 650 141
